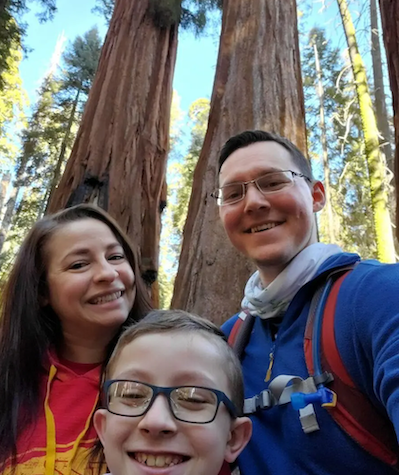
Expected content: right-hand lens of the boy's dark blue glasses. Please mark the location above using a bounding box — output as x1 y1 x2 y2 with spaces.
170 386 218 424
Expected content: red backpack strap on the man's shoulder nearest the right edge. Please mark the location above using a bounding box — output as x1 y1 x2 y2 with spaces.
304 271 398 466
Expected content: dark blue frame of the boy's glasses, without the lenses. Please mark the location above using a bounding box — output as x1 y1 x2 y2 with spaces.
103 379 238 424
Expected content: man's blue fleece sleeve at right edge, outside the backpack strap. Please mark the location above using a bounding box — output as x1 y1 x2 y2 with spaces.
335 261 399 438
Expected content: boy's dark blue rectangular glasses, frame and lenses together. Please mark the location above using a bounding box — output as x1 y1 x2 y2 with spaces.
103 379 237 424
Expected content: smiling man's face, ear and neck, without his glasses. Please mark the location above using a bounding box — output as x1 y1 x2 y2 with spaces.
219 142 325 285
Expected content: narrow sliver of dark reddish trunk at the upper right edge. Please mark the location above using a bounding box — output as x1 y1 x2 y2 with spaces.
380 0 399 245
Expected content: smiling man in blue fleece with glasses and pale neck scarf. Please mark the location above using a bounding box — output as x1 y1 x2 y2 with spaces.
215 131 399 475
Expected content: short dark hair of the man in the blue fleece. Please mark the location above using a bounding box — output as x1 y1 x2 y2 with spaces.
218 130 313 180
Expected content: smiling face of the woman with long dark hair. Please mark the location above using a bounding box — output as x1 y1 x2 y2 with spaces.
45 218 136 341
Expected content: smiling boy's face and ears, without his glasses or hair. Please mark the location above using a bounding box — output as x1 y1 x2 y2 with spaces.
94 332 251 475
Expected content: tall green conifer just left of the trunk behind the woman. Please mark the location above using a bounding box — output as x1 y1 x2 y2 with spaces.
0 28 101 271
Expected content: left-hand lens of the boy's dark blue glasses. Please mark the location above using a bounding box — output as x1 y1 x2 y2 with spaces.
108 381 152 416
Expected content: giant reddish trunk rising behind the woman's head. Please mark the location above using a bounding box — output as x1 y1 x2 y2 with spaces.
49 0 177 290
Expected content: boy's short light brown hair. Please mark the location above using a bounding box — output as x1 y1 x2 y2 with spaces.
105 310 244 415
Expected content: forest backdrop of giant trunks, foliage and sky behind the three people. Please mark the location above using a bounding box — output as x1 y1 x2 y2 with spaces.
0 0 398 322
